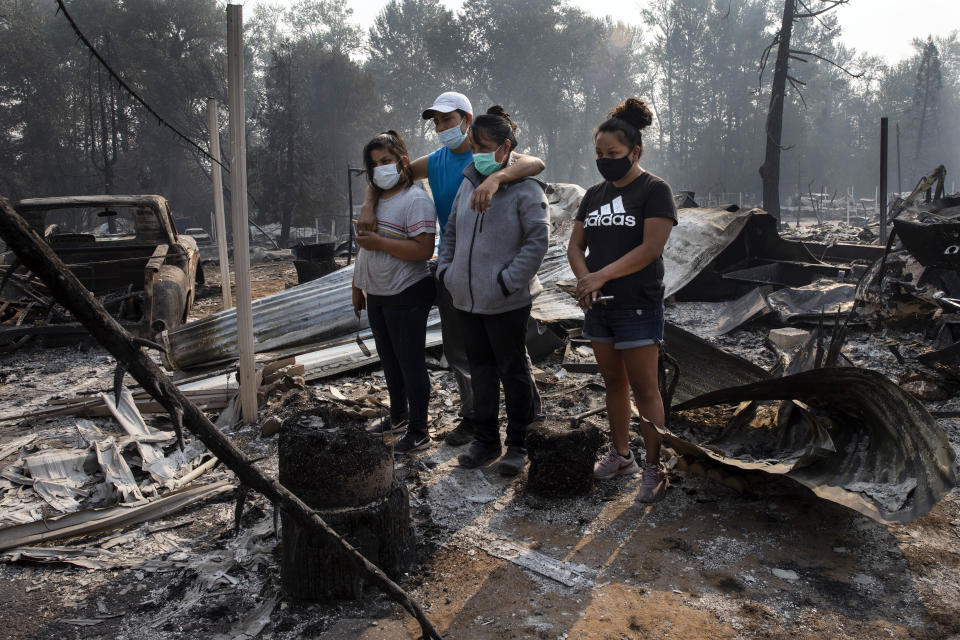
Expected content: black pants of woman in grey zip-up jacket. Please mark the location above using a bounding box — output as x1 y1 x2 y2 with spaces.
460 305 539 447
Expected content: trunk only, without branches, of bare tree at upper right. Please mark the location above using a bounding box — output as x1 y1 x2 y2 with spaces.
760 0 796 222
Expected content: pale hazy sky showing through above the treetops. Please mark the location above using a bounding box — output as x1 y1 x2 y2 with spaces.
231 0 960 62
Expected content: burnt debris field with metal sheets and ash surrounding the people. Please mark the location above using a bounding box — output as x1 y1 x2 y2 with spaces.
0 185 960 639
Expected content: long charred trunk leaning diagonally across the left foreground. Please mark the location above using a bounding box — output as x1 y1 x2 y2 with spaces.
0 197 441 640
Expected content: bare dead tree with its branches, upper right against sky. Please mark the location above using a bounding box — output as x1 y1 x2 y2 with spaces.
760 0 863 221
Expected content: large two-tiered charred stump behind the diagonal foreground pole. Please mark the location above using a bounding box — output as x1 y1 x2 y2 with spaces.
279 407 414 600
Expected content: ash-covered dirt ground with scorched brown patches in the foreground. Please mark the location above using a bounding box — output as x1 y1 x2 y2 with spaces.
0 262 960 640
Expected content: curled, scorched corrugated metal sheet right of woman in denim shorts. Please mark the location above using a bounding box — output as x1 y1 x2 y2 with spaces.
665 367 957 523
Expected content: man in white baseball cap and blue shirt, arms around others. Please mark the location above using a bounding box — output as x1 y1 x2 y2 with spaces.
357 91 546 445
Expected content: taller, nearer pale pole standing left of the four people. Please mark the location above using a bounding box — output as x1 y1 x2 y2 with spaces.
227 4 257 424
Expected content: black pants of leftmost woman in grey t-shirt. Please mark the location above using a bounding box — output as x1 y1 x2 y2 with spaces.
367 278 434 433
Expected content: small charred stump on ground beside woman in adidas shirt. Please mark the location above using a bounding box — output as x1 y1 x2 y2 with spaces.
526 419 604 497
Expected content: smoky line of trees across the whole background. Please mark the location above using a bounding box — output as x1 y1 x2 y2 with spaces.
0 0 960 245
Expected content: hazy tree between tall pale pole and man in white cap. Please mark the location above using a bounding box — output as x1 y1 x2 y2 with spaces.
248 2 385 245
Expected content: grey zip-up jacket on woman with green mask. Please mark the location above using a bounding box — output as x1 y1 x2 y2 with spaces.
437 163 550 315
